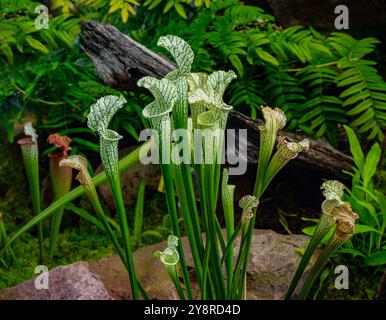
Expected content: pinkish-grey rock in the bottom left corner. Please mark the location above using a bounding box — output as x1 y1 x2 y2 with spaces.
0 262 112 300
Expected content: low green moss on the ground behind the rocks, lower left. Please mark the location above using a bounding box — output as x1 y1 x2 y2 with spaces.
0 189 170 289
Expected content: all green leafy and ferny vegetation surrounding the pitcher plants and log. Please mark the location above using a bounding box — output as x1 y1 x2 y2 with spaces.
0 0 386 296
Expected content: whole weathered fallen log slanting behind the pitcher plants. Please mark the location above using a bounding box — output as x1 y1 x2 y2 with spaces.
80 21 352 180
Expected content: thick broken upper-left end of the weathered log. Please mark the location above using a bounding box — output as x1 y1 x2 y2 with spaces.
80 21 176 91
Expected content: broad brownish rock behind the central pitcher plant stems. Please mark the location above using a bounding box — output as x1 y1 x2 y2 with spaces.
90 229 309 300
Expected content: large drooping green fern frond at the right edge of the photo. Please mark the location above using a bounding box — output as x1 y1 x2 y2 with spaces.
329 33 386 140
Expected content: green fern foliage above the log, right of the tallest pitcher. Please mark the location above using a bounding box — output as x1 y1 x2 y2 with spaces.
129 0 386 145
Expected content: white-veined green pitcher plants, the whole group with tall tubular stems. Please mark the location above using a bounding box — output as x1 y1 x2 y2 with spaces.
0 36 357 299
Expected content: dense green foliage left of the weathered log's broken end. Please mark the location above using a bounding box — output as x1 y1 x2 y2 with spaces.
0 0 146 155
